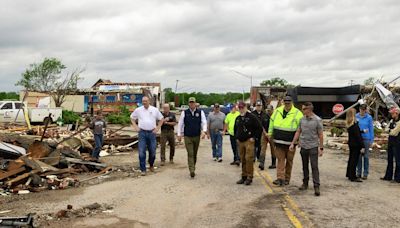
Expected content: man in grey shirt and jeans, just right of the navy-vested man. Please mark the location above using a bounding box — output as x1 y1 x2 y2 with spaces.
207 103 225 162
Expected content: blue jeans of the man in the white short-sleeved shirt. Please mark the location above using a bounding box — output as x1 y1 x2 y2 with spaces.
138 130 157 172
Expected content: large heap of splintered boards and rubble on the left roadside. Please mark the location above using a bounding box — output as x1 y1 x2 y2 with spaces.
0 129 112 195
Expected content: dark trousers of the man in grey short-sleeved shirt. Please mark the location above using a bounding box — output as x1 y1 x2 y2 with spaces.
300 147 320 187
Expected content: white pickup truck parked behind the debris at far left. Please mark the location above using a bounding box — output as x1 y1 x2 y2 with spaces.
0 101 62 123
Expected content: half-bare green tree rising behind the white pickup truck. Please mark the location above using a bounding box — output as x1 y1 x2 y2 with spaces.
16 58 84 107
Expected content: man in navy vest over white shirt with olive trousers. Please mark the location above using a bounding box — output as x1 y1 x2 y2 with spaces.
178 97 207 178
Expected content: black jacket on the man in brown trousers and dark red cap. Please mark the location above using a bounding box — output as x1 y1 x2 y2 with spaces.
234 112 262 142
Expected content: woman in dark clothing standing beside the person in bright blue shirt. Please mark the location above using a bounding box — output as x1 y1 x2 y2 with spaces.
346 108 364 182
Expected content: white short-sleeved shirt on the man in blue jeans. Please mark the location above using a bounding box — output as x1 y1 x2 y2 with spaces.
131 106 163 131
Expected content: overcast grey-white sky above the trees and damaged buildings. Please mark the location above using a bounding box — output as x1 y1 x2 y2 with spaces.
0 0 400 92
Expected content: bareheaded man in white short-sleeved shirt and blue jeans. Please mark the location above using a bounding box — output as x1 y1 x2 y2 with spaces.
131 97 163 176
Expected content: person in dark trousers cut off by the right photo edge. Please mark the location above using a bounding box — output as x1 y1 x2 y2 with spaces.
381 107 400 183
